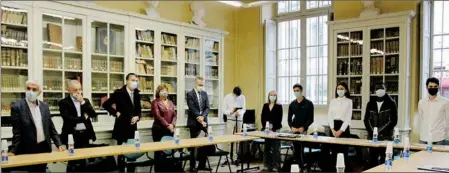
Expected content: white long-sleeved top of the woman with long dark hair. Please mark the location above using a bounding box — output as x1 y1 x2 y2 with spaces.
327 97 352 131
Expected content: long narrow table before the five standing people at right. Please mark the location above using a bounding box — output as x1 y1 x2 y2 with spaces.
240 131 449 152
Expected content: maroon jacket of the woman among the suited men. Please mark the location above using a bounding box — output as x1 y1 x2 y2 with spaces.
151 99 176 127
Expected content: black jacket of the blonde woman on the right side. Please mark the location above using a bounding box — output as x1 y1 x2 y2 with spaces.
261 103 283 131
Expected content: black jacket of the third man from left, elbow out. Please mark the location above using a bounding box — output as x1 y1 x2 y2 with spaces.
103 85 142 140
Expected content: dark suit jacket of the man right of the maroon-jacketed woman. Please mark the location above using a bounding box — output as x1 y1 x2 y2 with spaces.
187 89 209 127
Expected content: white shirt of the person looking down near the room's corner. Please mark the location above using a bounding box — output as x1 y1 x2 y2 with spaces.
223 93 246 120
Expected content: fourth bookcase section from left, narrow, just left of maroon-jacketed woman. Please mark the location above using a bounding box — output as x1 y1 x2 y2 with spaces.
135 28 155 120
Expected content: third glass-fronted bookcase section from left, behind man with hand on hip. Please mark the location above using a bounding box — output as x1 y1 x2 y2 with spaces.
90 20 126 112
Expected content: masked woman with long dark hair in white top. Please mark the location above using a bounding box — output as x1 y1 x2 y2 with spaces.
327 82 352 172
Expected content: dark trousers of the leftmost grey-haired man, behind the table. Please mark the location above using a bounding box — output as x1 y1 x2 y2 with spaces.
11 141 51 172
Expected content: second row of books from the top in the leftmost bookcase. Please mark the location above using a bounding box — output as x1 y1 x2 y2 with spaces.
2 25 28 47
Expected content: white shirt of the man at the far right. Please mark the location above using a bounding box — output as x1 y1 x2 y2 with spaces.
418 95 449 142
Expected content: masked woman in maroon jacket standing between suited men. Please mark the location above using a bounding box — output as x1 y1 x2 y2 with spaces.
151 84 177 172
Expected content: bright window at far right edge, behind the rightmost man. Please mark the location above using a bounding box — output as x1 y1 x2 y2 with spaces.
432 1 449 98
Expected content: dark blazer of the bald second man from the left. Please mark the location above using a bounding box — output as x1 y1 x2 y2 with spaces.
59 96 97 144
